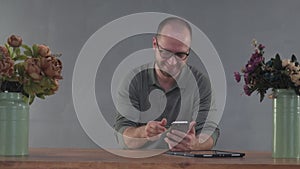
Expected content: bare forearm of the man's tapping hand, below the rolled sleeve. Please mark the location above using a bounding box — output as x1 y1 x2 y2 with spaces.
123 126 148 149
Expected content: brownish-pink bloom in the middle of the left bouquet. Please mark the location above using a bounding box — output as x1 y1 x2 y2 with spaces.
24 58 42 80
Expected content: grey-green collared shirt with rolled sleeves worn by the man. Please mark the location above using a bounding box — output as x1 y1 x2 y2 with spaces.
114 63 219 148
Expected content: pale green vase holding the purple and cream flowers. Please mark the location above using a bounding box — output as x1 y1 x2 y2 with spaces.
272 89 300 158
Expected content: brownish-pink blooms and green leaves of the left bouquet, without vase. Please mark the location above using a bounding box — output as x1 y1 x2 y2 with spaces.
0 35 62 104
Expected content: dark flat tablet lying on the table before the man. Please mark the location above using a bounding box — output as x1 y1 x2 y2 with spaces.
166 150 245 158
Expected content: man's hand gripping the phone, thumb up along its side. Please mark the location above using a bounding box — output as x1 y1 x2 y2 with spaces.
164 121 200 151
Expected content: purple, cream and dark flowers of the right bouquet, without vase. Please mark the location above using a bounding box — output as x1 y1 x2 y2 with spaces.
234 40 300 101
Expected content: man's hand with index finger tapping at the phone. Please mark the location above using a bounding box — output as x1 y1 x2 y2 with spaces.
145 118 167 141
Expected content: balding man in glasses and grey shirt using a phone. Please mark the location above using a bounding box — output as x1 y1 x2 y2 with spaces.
115 17 219 151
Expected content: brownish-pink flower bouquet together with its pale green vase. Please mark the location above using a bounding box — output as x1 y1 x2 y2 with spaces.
0 35 62 156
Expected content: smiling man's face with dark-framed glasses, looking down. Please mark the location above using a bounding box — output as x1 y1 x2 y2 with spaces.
153 31 190 78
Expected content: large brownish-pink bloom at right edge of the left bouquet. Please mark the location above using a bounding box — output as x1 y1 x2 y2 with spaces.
41 56 62 79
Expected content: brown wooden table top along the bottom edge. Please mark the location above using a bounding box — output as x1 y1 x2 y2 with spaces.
0 148 300 169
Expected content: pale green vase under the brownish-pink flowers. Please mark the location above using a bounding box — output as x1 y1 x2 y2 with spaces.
0 92 29 156
